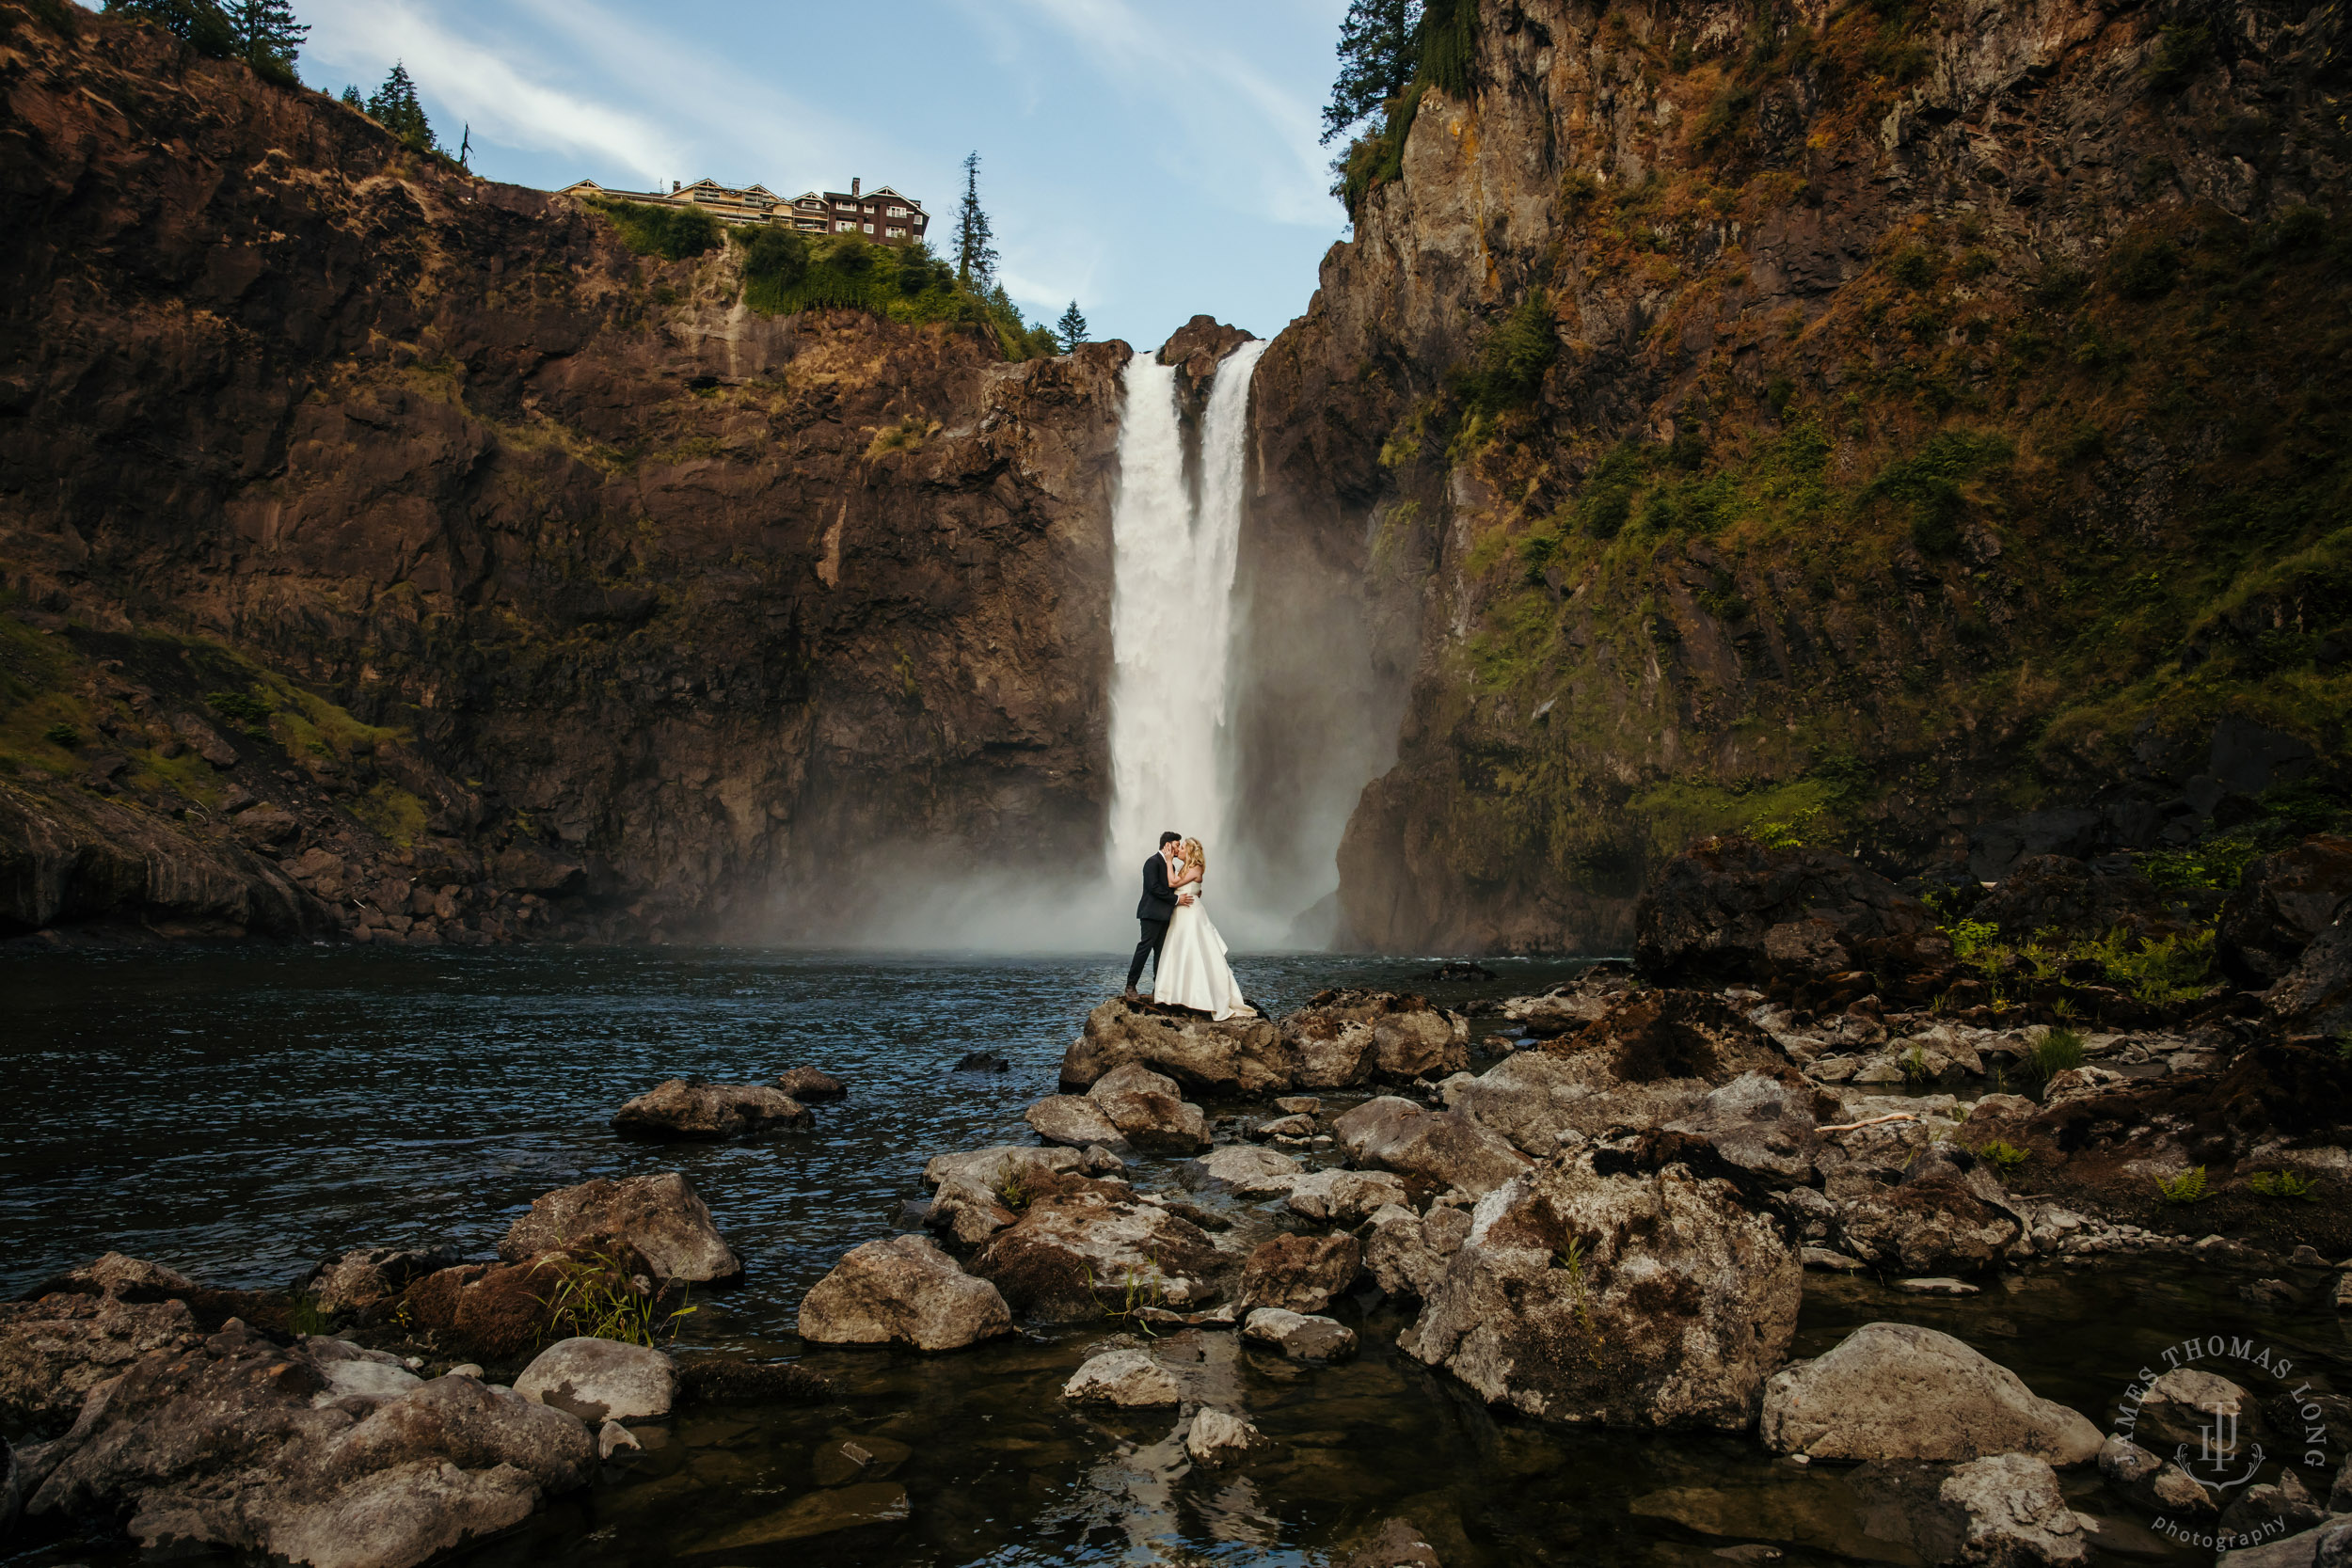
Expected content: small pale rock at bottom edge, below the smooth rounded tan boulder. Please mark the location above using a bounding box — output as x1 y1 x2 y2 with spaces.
1851 1453 2089 1568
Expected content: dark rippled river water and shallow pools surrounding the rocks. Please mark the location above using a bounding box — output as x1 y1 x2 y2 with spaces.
0 947 2352 1568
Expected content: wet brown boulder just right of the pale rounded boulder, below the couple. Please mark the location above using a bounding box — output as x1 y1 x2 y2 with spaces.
972 1173 1235 1323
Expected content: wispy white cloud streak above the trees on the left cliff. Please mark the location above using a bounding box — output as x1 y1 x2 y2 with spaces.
304 0 680 181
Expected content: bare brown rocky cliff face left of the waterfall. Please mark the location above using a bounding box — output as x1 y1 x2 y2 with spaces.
0 5 1127 941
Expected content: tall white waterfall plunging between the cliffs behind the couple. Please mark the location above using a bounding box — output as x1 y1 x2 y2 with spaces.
1108 341 1265 936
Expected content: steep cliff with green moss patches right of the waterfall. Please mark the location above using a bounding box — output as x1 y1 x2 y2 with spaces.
1254 0 2352 952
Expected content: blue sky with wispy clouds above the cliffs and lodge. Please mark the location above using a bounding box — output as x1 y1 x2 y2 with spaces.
296 0 1348 348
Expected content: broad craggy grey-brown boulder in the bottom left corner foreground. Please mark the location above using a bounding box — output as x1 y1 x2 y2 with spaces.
28 1322 596 1568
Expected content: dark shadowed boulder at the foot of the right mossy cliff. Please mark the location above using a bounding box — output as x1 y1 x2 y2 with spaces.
1632 834 1952 988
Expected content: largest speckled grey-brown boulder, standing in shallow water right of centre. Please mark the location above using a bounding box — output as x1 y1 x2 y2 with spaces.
1414 1149 1804 1432
